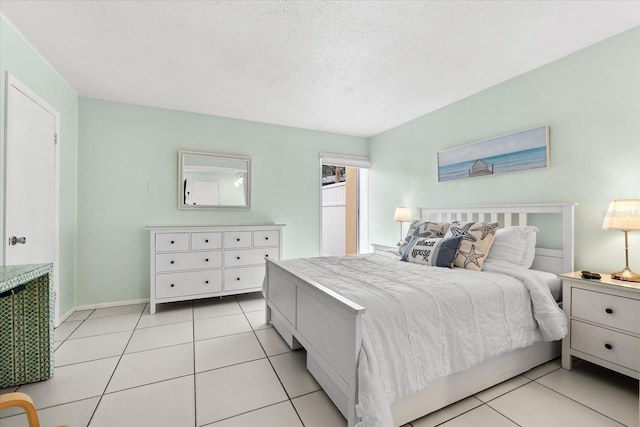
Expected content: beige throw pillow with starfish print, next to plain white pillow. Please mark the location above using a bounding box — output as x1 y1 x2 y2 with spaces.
446 221 499 271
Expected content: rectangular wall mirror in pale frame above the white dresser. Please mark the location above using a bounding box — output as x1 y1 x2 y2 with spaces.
178 151 251 209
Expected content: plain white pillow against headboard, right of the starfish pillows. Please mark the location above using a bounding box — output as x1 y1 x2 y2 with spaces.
487 226 538 268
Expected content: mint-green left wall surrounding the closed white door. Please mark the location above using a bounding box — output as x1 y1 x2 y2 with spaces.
0 18 78 314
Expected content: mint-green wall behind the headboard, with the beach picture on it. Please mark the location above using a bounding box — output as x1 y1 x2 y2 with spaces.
369 27 640 272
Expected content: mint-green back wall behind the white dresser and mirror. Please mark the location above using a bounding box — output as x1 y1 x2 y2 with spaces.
77 97 368 305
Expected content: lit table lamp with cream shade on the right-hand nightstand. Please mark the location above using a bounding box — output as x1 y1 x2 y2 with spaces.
602 199 640 282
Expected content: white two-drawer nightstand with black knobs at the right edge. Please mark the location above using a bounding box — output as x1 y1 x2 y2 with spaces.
558 271 640 379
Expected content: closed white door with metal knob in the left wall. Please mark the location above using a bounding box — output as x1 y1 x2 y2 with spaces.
3 74 59 319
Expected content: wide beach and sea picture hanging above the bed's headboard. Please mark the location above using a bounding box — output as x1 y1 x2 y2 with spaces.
438 125 549 182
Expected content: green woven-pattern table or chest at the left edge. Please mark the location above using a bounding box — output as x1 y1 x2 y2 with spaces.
0 264 53 388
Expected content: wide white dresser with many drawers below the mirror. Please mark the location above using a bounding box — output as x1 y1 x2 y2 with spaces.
147 224 284 314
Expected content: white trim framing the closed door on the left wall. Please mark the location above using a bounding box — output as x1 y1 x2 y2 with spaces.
2 71 61 326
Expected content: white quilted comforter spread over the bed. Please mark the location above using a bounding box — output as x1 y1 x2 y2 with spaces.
283 254 567 427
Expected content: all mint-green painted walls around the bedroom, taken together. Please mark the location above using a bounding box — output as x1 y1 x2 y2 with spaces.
0 12 640 313
